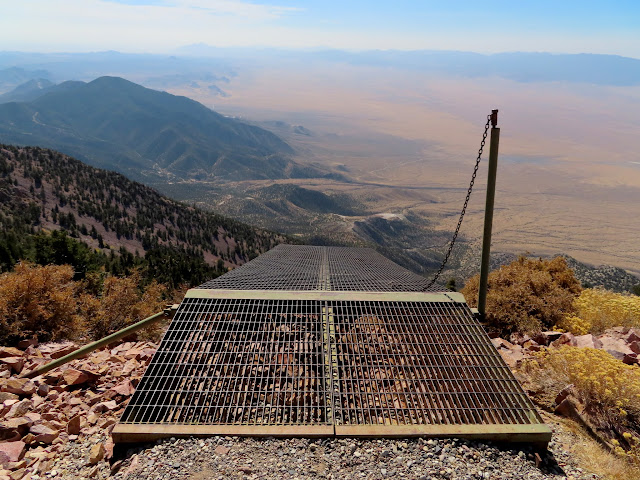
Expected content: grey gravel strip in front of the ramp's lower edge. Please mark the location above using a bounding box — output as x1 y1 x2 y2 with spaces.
91 437 599 480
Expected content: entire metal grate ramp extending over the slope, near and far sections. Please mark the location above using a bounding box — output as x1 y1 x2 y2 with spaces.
113 246 551 443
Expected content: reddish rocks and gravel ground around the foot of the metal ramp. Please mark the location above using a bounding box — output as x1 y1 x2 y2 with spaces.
0 331 640 480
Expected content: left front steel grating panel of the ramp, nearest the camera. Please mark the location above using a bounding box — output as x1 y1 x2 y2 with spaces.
121 298 331 434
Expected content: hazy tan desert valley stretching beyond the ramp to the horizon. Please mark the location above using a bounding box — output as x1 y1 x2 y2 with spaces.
0 51 640 288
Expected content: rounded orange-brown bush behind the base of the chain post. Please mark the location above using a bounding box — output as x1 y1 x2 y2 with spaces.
462 256 582 334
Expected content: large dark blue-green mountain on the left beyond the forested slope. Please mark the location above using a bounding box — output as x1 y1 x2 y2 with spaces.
0 77 326 182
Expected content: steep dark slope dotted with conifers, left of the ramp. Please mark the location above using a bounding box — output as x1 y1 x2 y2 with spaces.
0 145 285 284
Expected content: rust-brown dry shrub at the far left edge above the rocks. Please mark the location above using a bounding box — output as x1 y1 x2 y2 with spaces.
0 262 83 344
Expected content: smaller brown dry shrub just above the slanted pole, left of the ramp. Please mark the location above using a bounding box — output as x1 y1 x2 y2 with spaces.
82 271 167 338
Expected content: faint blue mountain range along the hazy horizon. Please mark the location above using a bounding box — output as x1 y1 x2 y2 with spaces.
0 50 640 88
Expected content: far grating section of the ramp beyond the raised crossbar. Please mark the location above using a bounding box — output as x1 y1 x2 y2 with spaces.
199 245 446 292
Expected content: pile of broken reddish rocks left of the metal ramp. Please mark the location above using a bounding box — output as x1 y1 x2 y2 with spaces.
0 342 156 480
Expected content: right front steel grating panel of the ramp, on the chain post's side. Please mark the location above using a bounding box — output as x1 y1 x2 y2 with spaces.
328 302 541 425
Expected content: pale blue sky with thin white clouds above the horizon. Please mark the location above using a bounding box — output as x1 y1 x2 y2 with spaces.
0 0 640 58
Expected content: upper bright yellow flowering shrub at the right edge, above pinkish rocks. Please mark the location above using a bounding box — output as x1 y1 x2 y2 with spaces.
558 288 640 335
